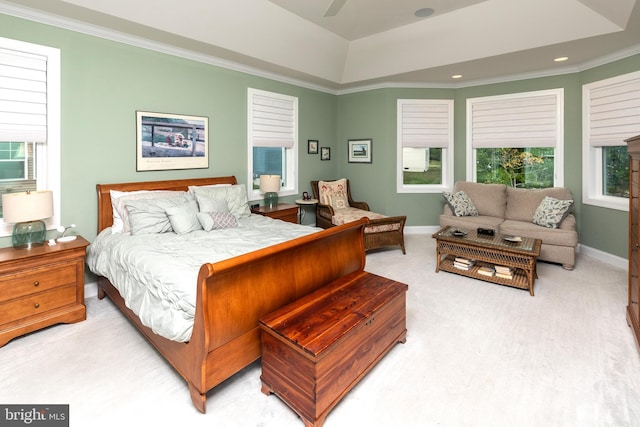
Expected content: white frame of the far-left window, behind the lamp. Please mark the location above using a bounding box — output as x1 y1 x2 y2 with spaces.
0 37 61 237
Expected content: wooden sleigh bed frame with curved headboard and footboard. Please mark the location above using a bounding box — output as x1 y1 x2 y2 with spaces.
96 176 367 413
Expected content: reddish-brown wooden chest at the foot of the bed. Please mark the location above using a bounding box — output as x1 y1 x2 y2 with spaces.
260 271 408 427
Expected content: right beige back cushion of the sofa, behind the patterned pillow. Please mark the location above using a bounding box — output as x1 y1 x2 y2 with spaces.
504 187 573 222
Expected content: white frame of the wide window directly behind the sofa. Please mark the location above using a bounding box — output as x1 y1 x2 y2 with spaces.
466 88 564 187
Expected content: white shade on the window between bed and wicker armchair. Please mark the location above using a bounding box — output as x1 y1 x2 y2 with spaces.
250 91 297 148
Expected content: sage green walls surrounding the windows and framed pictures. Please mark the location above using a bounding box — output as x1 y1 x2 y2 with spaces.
0 15 640 258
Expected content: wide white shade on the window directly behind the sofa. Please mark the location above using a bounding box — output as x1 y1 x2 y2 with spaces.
469 91 562 149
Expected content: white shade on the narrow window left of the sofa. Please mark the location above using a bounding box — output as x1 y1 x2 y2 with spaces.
399 100 452 148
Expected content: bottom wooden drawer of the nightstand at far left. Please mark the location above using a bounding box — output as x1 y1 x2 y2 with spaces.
0 284 76 325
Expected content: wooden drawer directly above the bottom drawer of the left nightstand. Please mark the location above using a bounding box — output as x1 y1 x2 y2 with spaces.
0 263 77 302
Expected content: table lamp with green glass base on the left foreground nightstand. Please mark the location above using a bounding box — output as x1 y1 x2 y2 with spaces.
2 191 53 249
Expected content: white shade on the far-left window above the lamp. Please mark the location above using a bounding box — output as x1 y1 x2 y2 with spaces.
0 49 47 142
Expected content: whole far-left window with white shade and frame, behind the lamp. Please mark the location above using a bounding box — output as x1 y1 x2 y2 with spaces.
0 38 60 236
